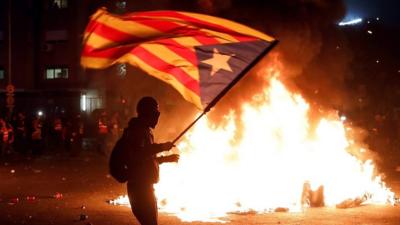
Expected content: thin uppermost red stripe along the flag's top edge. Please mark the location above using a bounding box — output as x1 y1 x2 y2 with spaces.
131 11 257 41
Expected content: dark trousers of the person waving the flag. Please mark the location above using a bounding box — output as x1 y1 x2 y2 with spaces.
128 181 158 225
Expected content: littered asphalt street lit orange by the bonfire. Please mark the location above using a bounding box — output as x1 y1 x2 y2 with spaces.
0 152 400 225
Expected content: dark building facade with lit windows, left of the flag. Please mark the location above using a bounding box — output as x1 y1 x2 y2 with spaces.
0 0 119 118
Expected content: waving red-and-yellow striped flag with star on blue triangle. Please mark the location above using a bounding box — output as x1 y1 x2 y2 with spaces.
81 8 275 109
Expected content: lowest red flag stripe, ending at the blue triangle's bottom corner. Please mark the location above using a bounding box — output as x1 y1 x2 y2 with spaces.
132 46 200 96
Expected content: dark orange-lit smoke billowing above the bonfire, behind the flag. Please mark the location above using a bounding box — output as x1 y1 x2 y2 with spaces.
161 0 351 125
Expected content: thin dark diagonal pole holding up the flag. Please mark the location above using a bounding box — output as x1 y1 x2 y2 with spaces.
172 40 278 144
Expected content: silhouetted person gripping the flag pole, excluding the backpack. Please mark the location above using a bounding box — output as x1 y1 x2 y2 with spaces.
124 97 179 225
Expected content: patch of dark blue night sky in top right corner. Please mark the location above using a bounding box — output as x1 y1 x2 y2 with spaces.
346 0 400 27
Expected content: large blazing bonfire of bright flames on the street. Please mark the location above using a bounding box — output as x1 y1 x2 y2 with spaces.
111 65 394 221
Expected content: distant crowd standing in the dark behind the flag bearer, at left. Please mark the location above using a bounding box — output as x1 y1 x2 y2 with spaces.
0 111 126 158
